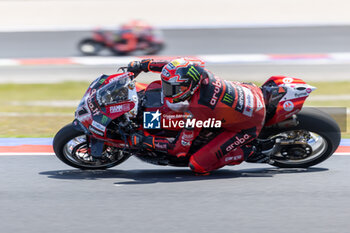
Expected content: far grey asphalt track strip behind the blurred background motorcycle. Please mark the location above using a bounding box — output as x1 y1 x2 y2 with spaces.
0 26 350 58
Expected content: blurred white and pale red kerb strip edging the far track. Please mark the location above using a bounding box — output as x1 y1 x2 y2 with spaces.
0 53 350 67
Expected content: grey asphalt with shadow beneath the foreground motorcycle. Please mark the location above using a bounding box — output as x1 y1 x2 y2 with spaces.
0 155 350 233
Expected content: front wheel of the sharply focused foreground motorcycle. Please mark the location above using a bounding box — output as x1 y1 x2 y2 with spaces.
53 124 129 170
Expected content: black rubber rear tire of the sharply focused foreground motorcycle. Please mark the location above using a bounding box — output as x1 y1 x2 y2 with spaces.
259 108 341 168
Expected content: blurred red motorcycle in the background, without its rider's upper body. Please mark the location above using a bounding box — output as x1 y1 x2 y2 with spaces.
78 29 164 56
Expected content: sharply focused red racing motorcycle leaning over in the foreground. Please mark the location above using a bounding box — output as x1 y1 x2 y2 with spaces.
53 69 340 169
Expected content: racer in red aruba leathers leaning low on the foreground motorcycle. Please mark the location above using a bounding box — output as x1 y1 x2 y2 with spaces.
128 58 265 174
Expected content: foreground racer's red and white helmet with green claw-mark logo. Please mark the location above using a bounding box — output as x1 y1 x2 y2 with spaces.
161 58 204 103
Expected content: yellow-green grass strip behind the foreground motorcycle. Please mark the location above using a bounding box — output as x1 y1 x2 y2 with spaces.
0 82 350 137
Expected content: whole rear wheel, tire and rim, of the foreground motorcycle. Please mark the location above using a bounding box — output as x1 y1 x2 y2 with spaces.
260 108 341 168
